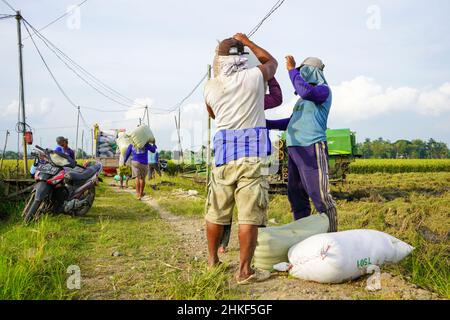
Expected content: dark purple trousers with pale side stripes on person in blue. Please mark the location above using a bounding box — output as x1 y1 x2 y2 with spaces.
288 142 337 232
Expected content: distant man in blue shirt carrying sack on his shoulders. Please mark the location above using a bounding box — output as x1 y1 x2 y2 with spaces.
124 143 157 200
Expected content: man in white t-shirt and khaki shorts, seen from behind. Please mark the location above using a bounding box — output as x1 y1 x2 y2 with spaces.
204 33 278 284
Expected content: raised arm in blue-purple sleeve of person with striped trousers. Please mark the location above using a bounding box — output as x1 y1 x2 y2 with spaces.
286 56 330 104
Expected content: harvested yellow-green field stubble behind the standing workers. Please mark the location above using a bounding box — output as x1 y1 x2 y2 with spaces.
148 172 450 298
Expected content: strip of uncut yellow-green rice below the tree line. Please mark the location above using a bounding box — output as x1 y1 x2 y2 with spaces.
350 159 450 174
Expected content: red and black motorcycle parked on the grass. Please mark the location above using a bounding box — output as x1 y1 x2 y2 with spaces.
22 146 103 223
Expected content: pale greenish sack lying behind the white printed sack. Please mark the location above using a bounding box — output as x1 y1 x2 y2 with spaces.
254 214 329 271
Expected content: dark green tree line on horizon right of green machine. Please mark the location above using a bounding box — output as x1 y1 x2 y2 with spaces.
357 138 450 159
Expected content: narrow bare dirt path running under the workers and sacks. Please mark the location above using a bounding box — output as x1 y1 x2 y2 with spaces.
117 185 438 300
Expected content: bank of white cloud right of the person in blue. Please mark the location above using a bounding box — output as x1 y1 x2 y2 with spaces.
331 76 450 122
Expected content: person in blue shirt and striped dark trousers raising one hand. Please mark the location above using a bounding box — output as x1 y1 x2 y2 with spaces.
267 56 337 232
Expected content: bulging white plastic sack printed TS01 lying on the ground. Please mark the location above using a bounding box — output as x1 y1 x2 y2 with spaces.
288 230 414 283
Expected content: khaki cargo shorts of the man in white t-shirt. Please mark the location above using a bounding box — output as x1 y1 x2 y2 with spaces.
205 158 269 226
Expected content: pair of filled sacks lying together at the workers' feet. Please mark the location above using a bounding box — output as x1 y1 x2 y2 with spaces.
254 215 414 283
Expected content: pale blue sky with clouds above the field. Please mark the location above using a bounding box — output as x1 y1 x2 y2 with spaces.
0 0 450 149
